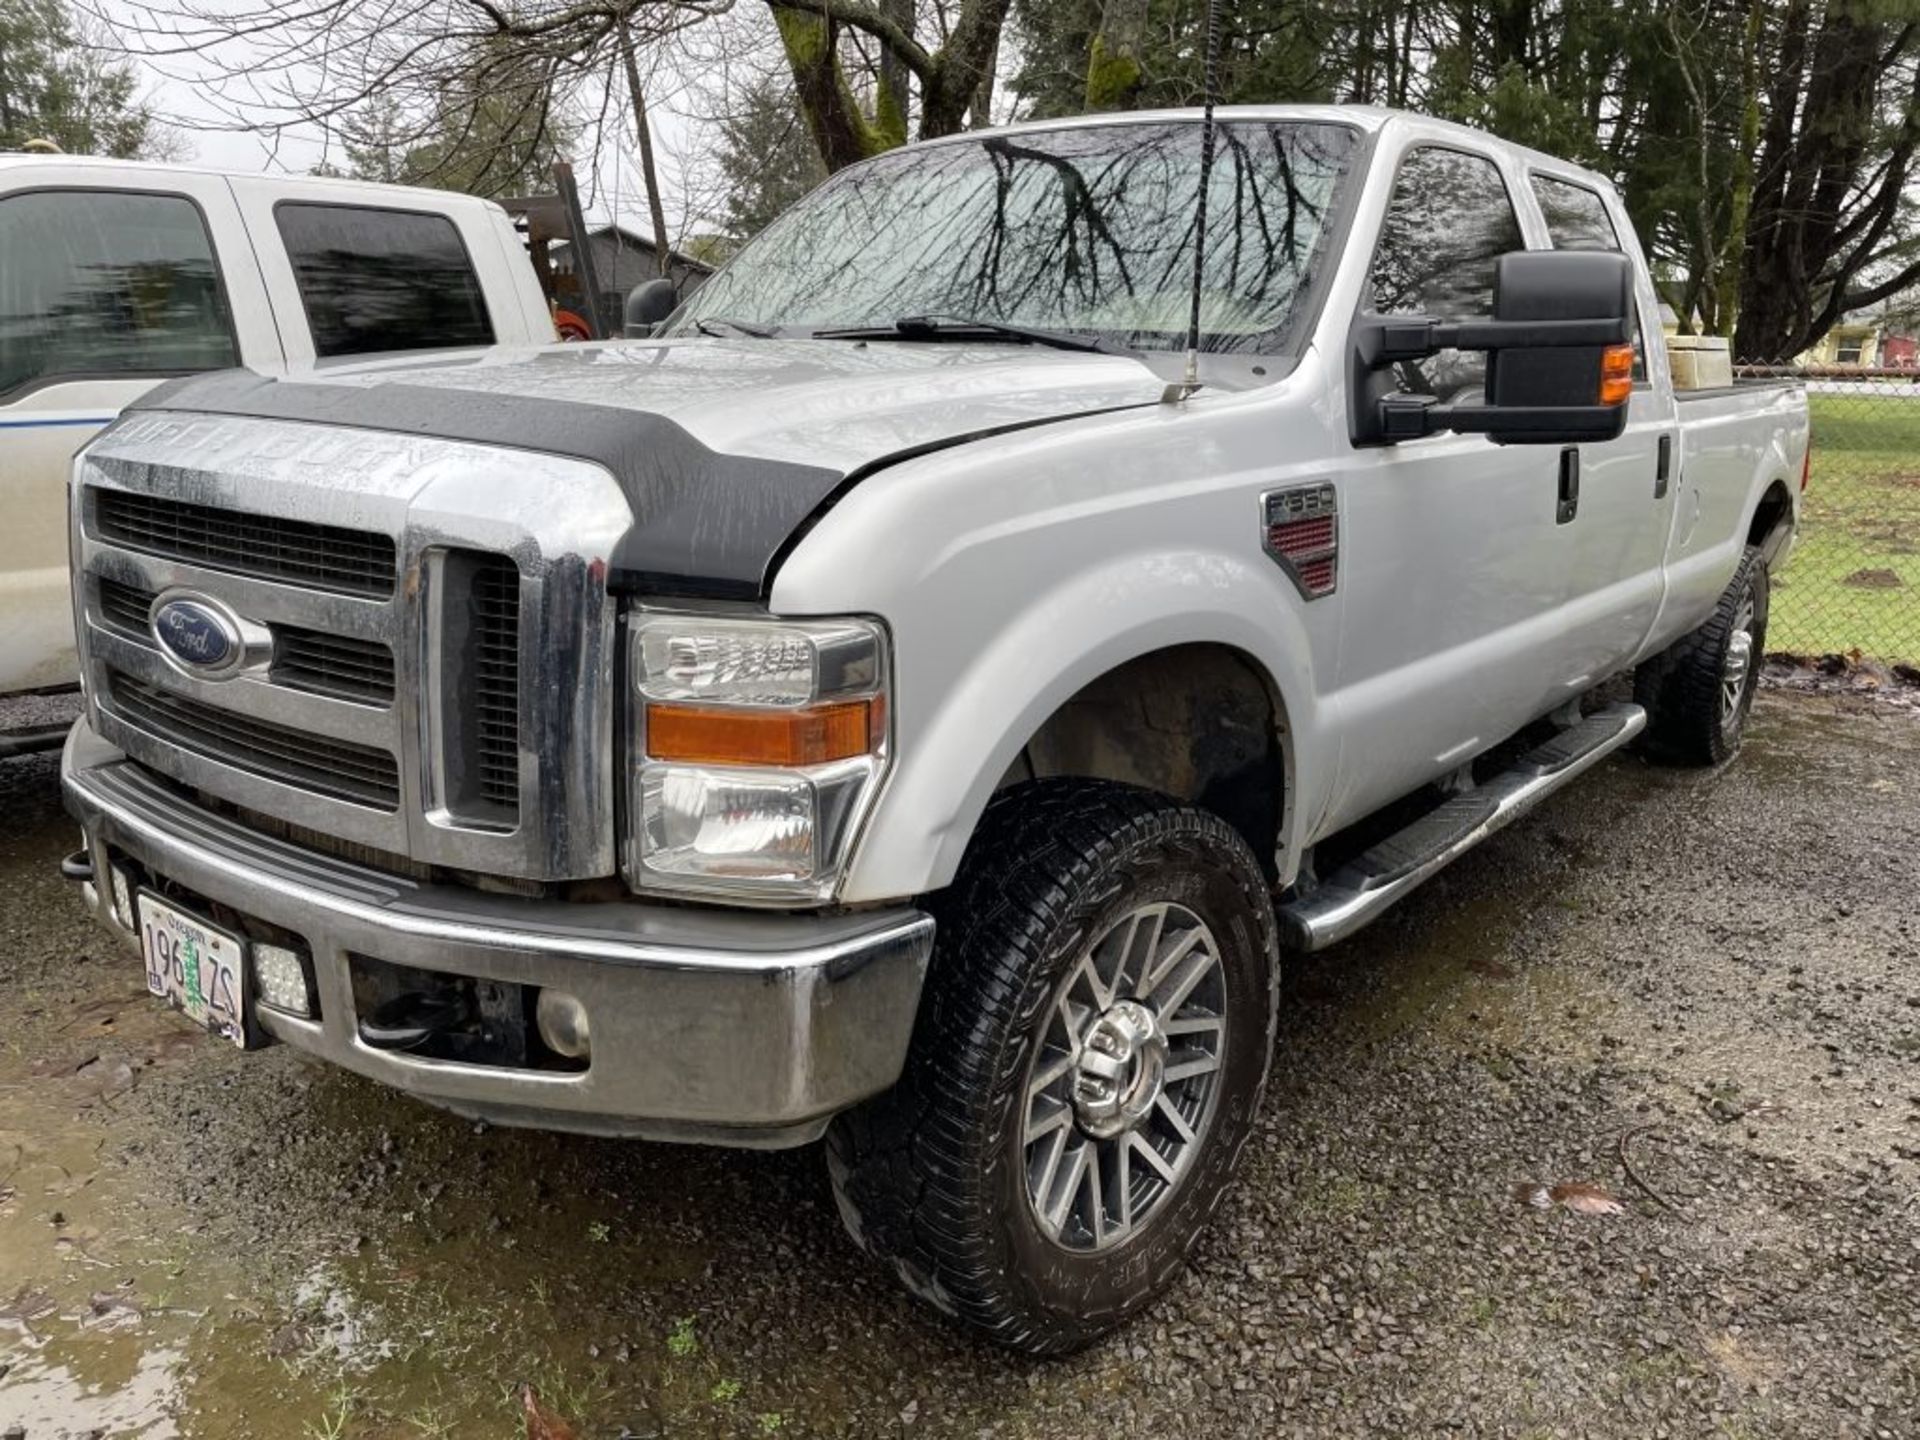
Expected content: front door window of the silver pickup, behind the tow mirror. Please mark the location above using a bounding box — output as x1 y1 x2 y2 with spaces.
1369 146 1526 401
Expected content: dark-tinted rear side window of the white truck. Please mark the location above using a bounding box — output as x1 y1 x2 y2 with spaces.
273 202 493 355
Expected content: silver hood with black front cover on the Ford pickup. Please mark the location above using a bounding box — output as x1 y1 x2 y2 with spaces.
132 338 1165 597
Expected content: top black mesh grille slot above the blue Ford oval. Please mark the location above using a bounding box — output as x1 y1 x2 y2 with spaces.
94 490 396 597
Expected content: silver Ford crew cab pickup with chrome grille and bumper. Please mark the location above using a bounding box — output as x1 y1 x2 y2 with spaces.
63 108 1807 1352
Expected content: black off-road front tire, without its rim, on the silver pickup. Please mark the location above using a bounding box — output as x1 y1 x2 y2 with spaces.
828 780 1279 1356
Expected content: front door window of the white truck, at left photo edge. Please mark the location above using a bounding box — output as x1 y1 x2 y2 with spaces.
0 190 240 396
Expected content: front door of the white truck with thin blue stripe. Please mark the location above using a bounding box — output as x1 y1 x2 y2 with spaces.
0 171 280 693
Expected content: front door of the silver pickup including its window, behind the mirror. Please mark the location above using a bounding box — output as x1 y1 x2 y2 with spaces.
1323 144 1605 828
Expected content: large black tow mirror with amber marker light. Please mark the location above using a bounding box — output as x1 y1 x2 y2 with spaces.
1348 250 1634 445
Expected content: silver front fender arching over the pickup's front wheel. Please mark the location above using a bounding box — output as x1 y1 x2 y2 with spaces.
770 372 1346 902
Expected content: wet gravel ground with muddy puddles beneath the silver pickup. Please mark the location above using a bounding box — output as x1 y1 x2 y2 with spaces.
0 693 1920 1440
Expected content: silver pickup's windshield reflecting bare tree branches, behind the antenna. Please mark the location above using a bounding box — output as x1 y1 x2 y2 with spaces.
672 121 1354 351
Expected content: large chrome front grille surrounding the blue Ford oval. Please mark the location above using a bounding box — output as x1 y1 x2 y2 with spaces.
71 413 634 883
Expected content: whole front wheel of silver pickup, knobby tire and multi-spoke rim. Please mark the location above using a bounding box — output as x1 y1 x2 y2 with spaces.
828 780 1279 1354
